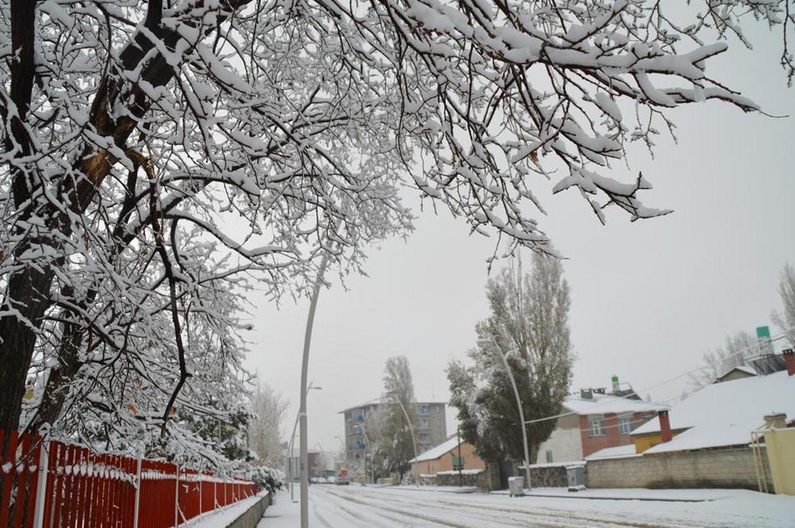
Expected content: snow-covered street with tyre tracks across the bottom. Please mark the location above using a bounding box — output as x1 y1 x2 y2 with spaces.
256 486 795 528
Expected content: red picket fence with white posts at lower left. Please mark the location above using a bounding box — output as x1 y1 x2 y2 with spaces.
0 430 258 528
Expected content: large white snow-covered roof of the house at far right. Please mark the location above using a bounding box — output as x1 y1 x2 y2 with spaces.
632 371 795 453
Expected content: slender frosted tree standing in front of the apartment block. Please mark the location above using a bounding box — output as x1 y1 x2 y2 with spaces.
377 356 418 480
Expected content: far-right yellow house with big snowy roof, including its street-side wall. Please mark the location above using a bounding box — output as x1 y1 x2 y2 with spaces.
586 350 795 495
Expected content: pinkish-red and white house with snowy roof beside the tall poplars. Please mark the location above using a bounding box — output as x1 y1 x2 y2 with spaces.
529 377 668 464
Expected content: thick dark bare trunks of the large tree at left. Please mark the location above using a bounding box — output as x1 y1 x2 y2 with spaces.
0 0 255 438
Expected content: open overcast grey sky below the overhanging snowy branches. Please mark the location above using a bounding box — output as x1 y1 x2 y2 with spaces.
248 26 795 456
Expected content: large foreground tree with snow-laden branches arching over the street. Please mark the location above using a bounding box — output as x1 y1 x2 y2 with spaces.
0 0 795 446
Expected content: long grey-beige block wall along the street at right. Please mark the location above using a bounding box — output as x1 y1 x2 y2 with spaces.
585 447 772 490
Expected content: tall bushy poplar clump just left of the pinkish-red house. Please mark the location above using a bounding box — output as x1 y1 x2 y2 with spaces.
447 253 573 462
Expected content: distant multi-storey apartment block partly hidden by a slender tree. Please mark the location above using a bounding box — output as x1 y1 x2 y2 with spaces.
340 400 447 470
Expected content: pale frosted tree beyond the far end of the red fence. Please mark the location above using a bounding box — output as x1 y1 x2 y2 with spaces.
248 382 287 468
